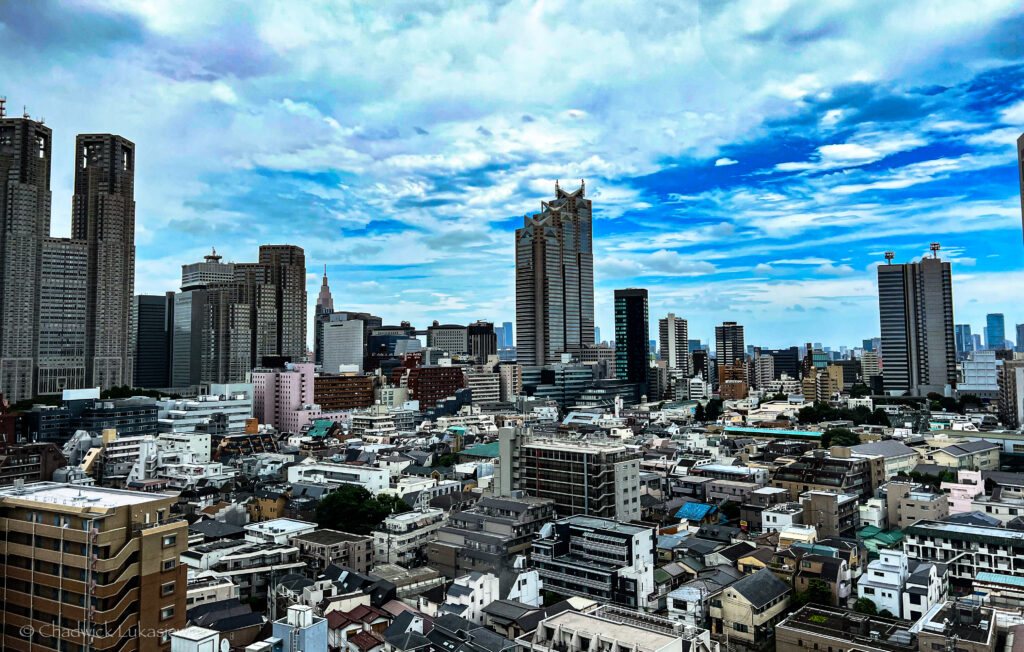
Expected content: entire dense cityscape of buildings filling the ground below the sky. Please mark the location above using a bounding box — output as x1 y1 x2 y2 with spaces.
9 104 1024 652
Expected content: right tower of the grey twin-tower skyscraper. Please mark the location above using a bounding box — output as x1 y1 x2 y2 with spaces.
71 134 135 388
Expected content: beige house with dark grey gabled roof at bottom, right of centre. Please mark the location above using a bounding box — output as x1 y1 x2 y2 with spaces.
710 568 793 650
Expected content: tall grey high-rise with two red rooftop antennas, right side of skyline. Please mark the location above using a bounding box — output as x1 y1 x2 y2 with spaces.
878 248 956 396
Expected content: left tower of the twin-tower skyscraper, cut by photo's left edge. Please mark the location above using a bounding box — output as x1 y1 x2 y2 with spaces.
0 109 51 401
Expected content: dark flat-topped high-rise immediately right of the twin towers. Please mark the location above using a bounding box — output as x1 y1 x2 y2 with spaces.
131 292 174 388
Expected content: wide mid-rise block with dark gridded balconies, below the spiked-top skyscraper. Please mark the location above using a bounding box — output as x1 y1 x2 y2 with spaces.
497 428 640 522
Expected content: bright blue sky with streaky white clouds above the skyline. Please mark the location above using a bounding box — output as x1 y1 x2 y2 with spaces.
6 0 1024 346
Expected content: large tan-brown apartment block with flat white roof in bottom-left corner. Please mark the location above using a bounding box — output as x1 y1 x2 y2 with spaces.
0 482 188 651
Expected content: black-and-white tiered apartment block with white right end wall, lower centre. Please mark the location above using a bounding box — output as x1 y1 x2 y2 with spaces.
532 516 654 609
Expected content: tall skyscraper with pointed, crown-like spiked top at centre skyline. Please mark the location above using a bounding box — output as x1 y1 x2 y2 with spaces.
515 182 598 366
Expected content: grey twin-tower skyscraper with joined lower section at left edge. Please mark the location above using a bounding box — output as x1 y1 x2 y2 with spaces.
0 104 135 402
